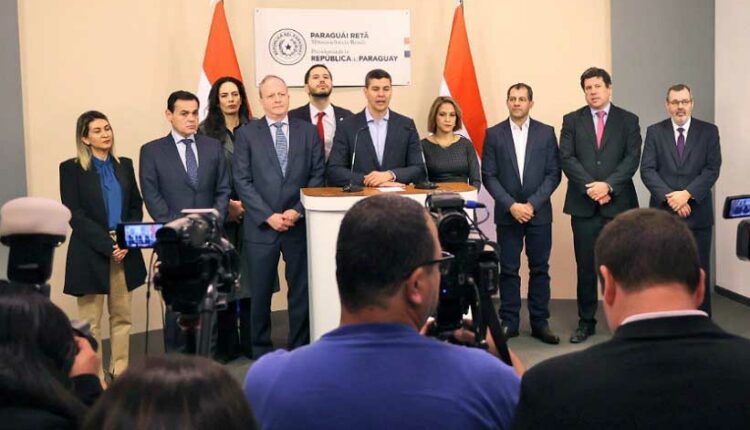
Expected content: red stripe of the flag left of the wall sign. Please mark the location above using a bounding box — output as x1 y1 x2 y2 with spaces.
203 1 242 85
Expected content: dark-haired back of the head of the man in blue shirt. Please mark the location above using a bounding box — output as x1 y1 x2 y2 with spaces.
336 194 436 312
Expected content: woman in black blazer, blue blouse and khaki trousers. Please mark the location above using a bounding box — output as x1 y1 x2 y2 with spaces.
60 111 146 377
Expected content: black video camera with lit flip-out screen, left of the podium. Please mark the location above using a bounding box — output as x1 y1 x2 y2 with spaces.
117 209 240 356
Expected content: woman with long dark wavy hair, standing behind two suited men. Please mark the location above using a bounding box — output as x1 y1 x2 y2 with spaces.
200 76 252 362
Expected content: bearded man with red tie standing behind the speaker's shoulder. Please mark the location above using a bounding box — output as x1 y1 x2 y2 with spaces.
289 64 353 159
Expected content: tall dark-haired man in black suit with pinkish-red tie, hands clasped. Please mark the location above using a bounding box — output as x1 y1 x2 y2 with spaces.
560 67 641 343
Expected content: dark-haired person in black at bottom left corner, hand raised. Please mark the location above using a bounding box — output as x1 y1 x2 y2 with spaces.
0 281 102 429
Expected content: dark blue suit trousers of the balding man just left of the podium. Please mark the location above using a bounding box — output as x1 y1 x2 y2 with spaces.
246 235 310 359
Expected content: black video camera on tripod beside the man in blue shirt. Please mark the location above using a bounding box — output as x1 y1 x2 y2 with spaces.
425 193 512 365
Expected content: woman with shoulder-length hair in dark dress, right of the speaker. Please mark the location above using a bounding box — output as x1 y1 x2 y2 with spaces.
421 96 482 190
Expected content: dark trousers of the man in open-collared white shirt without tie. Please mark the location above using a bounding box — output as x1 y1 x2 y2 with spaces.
497 223 552 330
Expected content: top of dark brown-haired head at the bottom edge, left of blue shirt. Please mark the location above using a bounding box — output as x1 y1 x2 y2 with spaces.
83 355 256 430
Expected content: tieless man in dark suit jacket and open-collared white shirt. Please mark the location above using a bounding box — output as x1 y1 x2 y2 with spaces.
482 83 560 344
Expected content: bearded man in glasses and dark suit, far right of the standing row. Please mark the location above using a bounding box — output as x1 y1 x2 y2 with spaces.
641 84 721 316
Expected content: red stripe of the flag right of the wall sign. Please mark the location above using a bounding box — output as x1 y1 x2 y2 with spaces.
443 4 487 157
